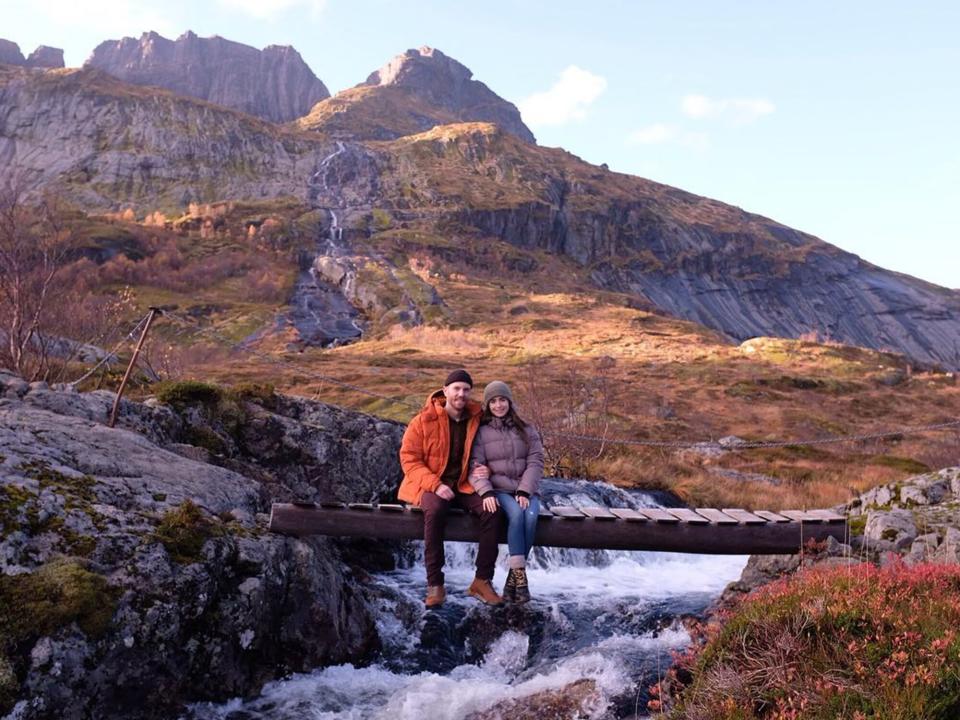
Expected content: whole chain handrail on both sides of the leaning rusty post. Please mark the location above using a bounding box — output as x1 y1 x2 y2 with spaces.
77 310 960 450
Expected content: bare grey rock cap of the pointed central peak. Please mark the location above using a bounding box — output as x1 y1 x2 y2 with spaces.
362 47 536 143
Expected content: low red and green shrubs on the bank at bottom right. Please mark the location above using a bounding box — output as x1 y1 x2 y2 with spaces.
653 562 960 720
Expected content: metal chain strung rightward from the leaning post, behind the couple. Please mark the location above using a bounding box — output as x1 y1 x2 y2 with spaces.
163 311 960 450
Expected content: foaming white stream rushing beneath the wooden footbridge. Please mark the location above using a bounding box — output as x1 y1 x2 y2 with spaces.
186 480 746 720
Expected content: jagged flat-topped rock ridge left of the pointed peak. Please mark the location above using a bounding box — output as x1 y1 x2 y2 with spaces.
85 32 330 122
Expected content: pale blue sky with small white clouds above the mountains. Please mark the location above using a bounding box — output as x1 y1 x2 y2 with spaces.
7 0 960 288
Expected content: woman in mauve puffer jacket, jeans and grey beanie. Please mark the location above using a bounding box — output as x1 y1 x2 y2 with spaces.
469 380 543 603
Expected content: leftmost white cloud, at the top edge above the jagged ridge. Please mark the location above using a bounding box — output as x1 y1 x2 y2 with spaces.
34 0 179 39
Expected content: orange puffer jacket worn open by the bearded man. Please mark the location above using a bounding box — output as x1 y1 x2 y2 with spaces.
397 390 482 505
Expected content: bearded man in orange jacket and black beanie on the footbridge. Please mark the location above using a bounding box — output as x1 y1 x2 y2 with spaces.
397 370 503 608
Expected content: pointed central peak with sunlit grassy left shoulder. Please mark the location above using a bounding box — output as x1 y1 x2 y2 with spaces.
298 47 536 143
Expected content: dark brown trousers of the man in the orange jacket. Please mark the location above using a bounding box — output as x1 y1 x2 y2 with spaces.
420 492 499 585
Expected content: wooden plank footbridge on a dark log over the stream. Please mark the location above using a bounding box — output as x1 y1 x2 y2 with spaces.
270 503 847 555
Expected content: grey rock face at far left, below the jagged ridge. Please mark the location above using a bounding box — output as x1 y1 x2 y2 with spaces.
0 67 338 210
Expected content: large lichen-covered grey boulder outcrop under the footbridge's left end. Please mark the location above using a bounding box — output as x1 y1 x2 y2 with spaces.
0 375 402 720
